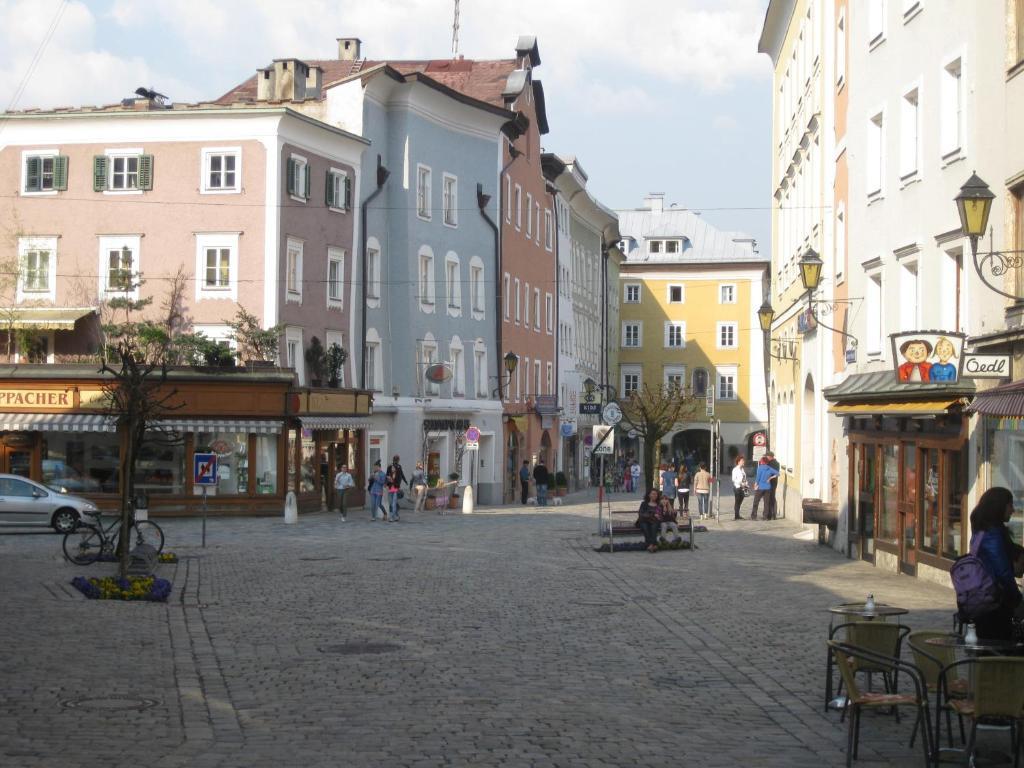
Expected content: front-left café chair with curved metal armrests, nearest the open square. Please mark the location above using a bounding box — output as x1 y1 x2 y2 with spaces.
828 640 934 768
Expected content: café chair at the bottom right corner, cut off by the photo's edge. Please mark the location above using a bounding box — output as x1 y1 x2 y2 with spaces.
939 656 1024 768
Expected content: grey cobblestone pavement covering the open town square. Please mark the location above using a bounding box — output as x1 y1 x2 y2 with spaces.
0 489 978 768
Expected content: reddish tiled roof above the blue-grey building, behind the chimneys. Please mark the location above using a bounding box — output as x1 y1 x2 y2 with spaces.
216 58 516 108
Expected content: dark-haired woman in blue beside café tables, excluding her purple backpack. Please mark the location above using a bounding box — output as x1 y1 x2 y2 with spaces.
968 486 1021 640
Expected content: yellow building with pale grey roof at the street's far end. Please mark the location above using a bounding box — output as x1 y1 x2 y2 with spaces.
616 195 768 470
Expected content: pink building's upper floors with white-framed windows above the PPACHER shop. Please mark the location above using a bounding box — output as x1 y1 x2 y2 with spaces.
0 94 368 385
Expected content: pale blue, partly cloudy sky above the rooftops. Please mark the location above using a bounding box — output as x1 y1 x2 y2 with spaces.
0 0 771 249
